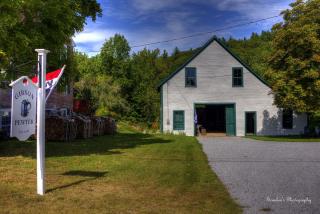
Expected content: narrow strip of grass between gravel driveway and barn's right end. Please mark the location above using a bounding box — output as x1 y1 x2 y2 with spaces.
246 136 320 142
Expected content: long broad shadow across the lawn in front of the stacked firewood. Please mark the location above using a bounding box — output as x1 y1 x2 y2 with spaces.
0 133 171 158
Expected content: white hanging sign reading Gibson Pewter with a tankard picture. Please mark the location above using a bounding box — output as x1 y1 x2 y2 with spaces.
10 76 37 141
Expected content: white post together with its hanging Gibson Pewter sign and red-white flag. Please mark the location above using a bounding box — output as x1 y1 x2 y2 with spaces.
10 49 66 195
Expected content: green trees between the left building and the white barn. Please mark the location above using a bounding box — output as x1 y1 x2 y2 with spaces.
75 34 198 123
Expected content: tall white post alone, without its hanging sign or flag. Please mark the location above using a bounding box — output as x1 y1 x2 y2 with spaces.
35 49 49 195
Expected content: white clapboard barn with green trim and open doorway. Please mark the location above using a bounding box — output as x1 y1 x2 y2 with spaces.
159 37 307 136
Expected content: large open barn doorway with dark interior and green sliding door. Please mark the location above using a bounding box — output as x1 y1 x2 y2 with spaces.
195 104 235 136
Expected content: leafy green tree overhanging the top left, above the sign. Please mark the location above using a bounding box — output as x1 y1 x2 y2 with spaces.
0 0 102 79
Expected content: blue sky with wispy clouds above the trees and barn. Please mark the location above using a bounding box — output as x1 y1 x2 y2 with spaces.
74 0 293 56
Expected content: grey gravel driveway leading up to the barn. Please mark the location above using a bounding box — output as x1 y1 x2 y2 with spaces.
198 137 320 214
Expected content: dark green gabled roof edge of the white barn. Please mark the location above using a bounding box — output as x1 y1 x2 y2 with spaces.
158 36 271 89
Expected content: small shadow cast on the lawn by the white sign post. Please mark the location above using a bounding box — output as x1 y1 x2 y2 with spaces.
46 170 107 193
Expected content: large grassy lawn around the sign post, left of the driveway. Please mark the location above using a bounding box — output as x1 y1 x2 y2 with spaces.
0 124 241 213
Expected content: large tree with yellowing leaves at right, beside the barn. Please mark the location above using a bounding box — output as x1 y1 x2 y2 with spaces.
268 0 320 113
